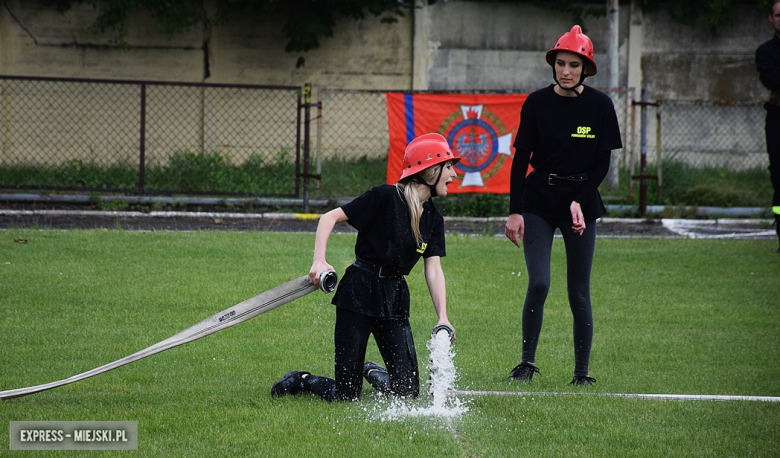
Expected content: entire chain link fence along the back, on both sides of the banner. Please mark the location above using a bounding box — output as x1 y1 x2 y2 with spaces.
0 76 771 206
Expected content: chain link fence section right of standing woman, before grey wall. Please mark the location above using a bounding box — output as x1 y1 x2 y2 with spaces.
630 100 772 207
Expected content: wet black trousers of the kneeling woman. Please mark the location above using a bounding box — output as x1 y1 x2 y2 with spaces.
304 307 420 401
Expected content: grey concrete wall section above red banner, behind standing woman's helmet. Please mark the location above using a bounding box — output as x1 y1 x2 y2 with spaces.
415 2 629 92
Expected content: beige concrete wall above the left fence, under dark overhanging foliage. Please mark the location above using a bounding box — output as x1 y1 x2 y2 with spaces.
0 0 413 90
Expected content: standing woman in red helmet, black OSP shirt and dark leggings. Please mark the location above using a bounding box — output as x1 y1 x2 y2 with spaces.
505 25 623 386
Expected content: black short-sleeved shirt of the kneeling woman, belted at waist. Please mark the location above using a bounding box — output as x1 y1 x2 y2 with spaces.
332 185 446 318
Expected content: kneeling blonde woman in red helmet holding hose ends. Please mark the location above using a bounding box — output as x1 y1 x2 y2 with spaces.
271 134 460 401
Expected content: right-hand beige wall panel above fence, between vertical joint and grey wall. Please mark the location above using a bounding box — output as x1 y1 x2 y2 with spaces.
209 4 412 90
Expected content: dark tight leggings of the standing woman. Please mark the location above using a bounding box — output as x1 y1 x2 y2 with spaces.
521 213 596 375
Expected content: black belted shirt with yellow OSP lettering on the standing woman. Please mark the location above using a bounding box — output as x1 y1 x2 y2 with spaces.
509 85 623 221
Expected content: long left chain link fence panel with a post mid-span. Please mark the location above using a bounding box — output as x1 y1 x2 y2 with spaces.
0 77 301 196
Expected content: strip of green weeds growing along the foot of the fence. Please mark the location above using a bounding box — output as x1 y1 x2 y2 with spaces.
0 154 772 211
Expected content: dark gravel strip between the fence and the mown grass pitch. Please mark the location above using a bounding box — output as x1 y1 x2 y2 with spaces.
0 203 776 239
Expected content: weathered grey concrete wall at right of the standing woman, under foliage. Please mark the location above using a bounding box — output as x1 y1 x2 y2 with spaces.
628 6 772 169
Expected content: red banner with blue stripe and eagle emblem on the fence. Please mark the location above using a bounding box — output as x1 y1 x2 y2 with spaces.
387 92 528 194
